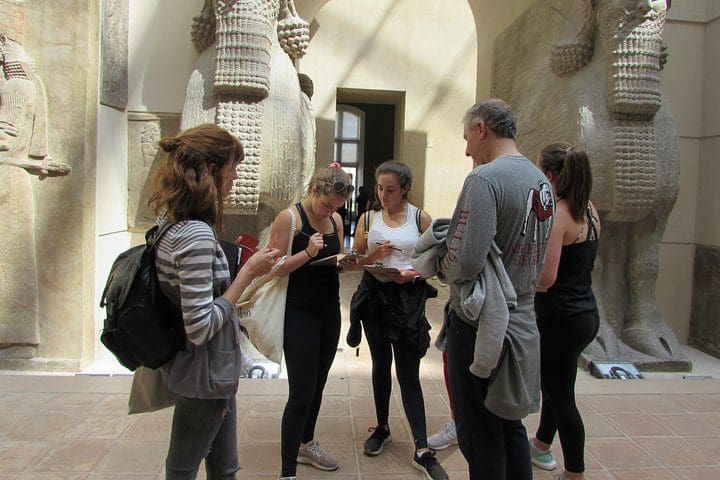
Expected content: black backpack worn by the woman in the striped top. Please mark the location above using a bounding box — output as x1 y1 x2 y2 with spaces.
100 220 185 370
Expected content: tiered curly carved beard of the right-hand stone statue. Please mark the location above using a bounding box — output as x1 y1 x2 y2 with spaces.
598 0 666 117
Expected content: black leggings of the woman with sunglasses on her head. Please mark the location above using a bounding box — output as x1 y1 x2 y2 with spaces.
280 304 340 477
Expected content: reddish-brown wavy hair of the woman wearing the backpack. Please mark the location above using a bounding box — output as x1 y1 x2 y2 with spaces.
148 123 245 229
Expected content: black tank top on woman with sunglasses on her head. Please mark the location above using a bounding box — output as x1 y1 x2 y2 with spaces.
287 203 340 312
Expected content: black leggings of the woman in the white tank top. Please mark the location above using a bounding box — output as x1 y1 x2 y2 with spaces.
362 318 427 449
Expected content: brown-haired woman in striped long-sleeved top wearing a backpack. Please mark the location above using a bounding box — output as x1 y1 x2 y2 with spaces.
149 124 279 480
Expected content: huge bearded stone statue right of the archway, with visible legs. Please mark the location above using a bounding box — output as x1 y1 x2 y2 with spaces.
493 0 691 370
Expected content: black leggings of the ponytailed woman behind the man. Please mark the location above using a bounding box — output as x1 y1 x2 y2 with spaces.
535 312 600 473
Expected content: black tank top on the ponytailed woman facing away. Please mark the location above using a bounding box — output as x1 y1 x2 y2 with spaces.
535 206 598 317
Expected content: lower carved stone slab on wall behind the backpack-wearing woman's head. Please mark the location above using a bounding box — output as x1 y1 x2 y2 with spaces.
128 112 180 231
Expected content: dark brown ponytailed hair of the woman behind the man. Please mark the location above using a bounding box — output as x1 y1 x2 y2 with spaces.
539 143 592 222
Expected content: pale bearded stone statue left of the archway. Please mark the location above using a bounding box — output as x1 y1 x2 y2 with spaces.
181 0 315 233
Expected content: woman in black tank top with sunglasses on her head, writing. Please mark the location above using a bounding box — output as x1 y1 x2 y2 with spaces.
270 162 353 479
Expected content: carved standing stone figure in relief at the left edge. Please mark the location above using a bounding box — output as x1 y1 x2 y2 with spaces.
0 34 70 359
